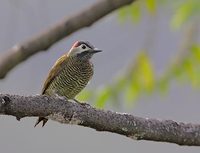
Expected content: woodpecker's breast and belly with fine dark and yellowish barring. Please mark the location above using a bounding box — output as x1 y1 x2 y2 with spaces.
49 61 93 99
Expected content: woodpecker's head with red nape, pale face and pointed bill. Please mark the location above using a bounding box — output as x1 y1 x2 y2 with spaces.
68 41 101 60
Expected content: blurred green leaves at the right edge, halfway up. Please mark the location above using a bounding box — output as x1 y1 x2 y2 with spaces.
159 45 200 89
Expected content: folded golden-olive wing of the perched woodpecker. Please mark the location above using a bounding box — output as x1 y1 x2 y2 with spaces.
42 54 68 94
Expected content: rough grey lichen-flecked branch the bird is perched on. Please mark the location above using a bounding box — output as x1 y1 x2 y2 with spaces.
0 94 200 146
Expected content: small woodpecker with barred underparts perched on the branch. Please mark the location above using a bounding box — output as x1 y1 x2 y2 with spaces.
35 41 102 127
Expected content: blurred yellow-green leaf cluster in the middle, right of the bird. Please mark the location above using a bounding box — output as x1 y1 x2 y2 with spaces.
124 51 154 105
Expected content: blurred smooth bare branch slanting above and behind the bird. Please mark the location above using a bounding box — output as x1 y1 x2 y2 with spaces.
0 0 135 79
